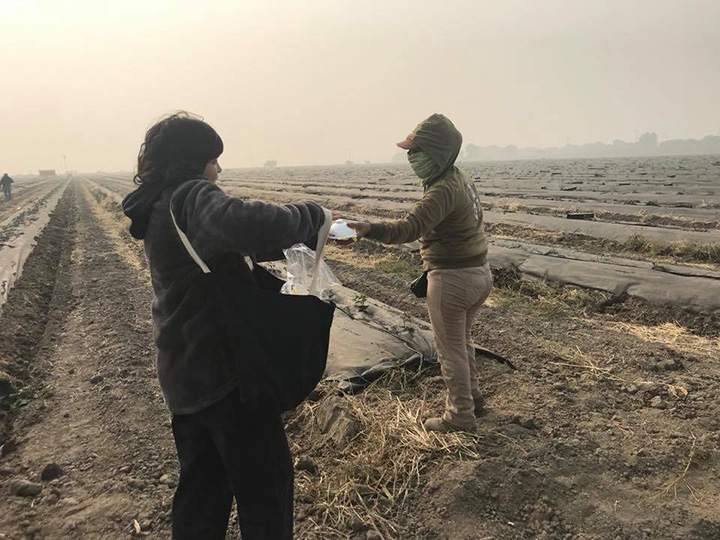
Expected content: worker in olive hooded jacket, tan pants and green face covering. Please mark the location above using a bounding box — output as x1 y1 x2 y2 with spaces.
348 114 493 431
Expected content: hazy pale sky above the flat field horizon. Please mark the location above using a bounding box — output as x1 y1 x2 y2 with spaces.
0 0 720 172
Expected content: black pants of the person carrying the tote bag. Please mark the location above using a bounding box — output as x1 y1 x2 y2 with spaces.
172 392 293 540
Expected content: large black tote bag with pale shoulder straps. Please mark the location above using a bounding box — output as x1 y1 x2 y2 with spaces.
170 205 335 411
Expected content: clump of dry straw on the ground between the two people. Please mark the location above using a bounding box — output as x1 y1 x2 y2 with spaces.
296 371 479 539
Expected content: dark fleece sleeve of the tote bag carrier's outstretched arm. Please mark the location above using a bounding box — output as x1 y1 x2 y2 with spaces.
172 180 325 259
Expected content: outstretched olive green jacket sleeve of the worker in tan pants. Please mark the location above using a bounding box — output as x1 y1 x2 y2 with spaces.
367 182 455 244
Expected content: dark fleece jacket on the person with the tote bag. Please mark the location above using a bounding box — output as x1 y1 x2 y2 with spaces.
123 179 325 414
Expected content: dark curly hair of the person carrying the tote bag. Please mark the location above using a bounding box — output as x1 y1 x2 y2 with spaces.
133 111 224 184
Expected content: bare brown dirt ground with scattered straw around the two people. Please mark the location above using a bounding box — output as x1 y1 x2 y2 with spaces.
0 166 720 540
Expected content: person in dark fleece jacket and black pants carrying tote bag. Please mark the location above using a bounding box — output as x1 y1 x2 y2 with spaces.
123 113 325 540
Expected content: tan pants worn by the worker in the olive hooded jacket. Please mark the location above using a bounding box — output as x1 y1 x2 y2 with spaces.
427 264 493 429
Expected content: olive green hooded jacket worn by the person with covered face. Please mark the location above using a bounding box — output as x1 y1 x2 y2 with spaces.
367 114 488 270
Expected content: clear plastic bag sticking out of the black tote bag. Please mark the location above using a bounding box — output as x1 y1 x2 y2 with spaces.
280 244 340 300
